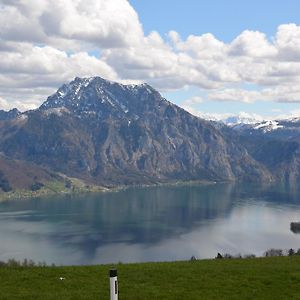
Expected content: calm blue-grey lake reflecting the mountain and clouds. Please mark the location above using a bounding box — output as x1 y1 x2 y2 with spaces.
0 184 300 265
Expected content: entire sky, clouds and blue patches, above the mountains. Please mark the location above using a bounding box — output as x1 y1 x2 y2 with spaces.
0 0 300 119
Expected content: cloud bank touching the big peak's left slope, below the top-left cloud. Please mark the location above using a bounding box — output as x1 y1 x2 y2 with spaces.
0 45 117 110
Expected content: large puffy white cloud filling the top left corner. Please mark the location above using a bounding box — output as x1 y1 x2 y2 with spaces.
0 0 143 49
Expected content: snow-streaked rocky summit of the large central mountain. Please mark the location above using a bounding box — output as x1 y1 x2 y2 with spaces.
39 77 172 122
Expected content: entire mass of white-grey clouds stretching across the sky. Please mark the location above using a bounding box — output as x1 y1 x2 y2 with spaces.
0 0 300 109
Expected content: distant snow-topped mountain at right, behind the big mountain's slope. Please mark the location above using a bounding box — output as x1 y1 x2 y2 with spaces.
221 118 300 183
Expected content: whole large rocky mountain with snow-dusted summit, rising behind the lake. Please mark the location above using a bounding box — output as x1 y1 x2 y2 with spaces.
0 77 272 191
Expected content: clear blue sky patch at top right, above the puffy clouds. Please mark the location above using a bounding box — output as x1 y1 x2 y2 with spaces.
129 0 300 42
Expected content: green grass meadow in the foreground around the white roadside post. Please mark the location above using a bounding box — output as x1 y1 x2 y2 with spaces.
0 256 300 300
